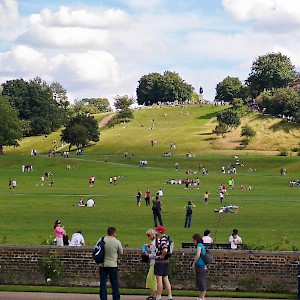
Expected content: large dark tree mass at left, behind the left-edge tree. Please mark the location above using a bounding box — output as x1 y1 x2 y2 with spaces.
2 77 68 135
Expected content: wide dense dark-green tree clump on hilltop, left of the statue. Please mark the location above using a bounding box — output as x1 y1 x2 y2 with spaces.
136 71 194 105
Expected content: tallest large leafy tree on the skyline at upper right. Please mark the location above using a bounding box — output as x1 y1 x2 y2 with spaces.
246 52 297 96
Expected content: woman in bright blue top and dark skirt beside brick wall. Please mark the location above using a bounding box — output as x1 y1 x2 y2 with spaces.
192 233 207 300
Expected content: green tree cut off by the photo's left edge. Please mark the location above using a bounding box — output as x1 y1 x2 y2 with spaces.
0 95 22 155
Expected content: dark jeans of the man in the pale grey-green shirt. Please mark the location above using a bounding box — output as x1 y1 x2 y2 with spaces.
99 267 120 300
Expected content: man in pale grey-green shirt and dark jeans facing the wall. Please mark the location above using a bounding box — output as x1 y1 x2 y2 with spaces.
99 227 123 300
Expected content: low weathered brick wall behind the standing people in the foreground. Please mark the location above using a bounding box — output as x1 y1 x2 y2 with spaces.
0 245 300 293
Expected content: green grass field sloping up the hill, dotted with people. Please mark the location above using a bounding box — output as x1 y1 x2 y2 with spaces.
0 106 300 250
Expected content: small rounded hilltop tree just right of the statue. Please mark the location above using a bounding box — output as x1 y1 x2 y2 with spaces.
216 76 246 103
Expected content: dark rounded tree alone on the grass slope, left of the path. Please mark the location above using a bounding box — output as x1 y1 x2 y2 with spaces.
61 115 100 147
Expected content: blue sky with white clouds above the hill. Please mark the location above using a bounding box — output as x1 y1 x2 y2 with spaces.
0 0 300 103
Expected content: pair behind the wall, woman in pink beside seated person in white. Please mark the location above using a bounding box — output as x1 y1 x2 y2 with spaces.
53 219 85 247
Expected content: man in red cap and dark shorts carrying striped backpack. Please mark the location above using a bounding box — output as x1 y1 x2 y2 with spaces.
154 226 173 300
